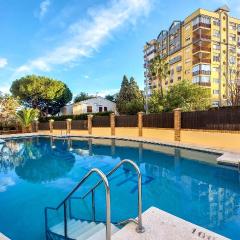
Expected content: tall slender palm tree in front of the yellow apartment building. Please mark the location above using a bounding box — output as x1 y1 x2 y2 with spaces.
150 56 170 97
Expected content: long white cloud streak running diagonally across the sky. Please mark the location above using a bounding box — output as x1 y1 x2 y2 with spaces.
16 0 153 73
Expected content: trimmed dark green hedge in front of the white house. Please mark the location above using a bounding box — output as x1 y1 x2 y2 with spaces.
39 112 112 122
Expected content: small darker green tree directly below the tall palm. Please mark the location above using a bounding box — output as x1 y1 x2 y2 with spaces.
148 90 165 113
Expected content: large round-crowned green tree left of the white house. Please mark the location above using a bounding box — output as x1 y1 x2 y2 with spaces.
10 75 72 116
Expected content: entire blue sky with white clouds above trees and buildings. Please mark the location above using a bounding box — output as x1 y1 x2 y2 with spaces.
0 0 240 95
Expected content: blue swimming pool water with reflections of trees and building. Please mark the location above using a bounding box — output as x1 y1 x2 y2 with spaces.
0 137 240 240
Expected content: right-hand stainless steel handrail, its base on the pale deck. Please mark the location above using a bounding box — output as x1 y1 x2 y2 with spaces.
82 159 145 233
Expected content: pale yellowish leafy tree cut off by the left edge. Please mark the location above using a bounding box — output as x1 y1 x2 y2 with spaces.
0 94 19 128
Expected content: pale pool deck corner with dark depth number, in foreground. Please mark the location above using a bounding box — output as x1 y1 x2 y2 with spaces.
112 207 228 240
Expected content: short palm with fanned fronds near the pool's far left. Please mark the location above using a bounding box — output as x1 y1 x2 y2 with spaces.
16 108 39 132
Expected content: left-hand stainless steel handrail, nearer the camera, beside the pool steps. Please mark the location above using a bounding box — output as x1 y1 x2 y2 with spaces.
45 168 111 240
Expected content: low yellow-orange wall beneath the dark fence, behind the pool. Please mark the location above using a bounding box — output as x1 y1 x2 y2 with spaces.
39 127 240 152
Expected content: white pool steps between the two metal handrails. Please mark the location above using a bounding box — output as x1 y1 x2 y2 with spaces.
50 219 119 240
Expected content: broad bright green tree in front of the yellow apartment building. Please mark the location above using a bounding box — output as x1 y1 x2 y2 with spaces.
164 80 211 111
